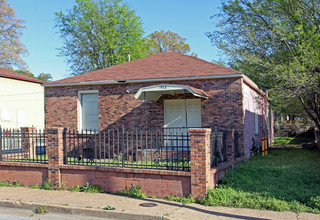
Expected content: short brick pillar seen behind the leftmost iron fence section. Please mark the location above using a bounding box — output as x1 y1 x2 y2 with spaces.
21 127 36 158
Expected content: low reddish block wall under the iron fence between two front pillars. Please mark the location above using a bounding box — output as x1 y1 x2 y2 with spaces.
61 165 191 198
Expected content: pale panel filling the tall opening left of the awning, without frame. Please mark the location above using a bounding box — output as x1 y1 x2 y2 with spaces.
81 93 99 130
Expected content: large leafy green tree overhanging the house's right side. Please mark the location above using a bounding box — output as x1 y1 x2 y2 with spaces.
207 0 320 146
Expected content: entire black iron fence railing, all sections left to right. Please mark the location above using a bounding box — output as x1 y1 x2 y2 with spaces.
0 127 241 168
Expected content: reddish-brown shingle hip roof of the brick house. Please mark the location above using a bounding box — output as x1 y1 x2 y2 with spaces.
49 51 239 84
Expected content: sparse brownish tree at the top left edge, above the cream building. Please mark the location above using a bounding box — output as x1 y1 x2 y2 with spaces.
0 0 27 70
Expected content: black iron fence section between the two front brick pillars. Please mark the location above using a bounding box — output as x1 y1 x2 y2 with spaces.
64 128 190 171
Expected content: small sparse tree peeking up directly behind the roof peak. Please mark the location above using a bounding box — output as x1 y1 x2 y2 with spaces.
148 30 197 56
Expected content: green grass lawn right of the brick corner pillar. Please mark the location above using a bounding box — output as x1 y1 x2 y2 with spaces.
198 149 320 213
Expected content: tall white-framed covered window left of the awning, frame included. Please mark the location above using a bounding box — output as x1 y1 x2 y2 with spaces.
78 90 99 131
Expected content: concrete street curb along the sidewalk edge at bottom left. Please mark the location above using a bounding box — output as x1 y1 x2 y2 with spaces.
0 200 170 220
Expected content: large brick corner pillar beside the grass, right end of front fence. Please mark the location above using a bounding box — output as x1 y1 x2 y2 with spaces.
189 128 211 198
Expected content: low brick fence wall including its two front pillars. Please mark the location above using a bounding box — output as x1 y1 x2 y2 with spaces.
0 128 232 198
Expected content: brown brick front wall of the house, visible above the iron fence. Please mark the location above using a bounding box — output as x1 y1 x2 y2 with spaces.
45 79 244 149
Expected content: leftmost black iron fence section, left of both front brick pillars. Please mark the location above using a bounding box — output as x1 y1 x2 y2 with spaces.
0 128 48 163
